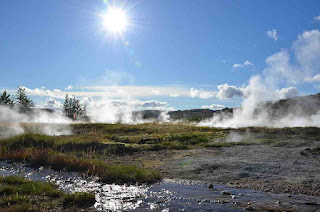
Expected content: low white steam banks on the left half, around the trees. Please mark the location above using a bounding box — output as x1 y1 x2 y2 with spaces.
0 104 170 138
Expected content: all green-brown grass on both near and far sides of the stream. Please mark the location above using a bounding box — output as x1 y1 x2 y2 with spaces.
0 123 320 211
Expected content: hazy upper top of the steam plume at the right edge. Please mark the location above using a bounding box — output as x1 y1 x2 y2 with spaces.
263 30 320 86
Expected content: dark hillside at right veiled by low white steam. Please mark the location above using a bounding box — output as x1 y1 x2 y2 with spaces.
199 94 320 128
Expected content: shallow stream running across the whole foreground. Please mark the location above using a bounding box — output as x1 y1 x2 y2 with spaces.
0 161 320 211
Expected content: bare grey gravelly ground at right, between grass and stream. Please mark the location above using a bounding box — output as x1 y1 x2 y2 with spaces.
113 141 320 196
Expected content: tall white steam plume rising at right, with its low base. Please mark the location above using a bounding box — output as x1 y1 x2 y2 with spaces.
199 30 320 128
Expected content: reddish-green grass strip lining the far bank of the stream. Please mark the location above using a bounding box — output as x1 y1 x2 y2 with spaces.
0 148 161 184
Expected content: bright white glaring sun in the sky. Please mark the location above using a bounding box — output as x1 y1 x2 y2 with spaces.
101 7 128 33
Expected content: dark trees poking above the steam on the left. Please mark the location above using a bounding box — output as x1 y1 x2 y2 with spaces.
0 86 88 119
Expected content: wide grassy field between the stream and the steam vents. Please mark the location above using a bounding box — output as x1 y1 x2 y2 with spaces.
0 123 320 183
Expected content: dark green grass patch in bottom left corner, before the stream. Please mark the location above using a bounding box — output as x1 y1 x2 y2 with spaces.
0 176 95 211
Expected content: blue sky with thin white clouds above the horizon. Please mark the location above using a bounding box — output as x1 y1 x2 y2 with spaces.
0 0 320 109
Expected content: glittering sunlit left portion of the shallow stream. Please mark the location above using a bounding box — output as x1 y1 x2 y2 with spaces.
0 162 156 211
